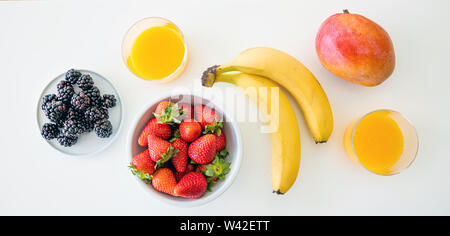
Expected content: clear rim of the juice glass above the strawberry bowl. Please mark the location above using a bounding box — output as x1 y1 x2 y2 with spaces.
121 16 189 83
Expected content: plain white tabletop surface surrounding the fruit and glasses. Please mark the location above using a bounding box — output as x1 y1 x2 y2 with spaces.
0 0 450 215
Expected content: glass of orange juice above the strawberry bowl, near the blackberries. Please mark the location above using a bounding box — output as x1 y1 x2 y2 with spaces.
122 17 188 82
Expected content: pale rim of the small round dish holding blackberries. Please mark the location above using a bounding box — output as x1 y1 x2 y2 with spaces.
36 69 125 158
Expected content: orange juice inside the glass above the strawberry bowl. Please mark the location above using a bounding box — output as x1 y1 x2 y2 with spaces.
127 23 186 80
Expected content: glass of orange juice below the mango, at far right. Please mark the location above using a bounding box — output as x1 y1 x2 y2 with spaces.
344 110 419 175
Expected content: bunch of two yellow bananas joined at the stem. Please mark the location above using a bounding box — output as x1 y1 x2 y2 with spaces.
202 47 333 194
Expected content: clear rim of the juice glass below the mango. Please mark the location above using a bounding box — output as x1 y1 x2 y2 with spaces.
351 109 420 176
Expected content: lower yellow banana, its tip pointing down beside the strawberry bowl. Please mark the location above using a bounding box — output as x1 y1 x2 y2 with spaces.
203 73 301 194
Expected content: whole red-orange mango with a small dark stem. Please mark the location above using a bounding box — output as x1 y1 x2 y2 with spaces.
316 10 395 87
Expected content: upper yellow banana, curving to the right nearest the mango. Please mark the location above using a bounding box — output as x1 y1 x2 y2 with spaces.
203 47 333 143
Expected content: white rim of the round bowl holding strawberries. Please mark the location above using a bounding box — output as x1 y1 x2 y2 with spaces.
126 91 243 207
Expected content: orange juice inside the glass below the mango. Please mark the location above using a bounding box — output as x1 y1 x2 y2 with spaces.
345 110 404 174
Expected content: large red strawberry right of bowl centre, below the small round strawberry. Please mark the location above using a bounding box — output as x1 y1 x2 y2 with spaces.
188 134 216 164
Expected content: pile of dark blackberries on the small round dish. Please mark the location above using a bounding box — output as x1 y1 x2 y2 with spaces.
41 69 117 147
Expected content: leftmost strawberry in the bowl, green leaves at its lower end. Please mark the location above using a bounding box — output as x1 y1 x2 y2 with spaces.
129 150 155 184
